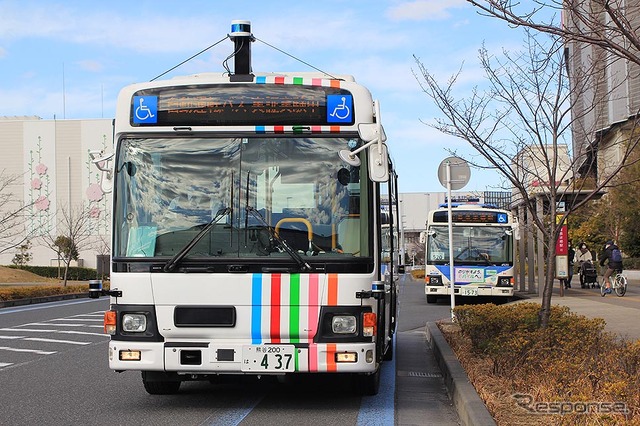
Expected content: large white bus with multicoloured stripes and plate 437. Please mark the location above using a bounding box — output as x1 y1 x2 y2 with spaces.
90 21 399 394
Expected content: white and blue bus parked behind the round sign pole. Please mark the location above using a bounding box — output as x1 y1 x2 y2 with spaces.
423 204 518 303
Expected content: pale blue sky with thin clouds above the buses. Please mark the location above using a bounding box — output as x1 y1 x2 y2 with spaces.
0 0 523 192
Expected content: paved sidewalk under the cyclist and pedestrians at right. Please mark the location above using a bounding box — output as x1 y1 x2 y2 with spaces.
515 271 640 340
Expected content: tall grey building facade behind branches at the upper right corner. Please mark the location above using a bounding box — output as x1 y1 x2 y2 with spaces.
563 0 640 182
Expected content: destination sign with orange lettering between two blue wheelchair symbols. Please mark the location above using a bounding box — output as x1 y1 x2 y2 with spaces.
130 84 355 127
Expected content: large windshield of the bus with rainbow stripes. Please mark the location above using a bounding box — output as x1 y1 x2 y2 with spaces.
113 136 372 260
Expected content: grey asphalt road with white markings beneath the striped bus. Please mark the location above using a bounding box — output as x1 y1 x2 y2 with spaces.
0 277 458 426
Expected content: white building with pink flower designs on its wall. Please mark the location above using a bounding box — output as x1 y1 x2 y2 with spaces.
0 117 113 268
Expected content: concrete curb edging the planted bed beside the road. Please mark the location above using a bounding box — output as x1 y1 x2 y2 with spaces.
425 322 496 426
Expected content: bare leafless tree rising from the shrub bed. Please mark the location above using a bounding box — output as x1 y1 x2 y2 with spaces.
415 31 637 327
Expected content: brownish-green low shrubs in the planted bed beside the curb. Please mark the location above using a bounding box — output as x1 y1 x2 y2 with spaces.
454 303 640 424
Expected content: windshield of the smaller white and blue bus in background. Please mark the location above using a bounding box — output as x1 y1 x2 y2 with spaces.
427 225 513 265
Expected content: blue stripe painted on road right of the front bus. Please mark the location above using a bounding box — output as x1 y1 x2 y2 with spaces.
356 334 397 426
